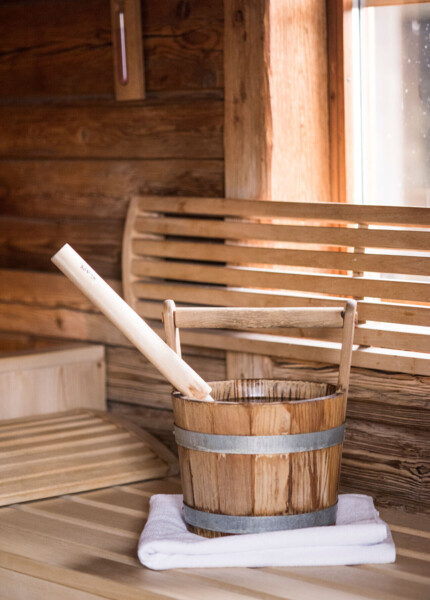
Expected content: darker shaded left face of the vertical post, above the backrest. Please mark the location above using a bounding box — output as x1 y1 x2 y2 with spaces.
224 0 271 200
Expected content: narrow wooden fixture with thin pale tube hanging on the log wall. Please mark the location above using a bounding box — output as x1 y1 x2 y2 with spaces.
110 0 145 100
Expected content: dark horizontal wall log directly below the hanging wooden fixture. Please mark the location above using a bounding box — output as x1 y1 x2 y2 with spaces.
0 100 224 160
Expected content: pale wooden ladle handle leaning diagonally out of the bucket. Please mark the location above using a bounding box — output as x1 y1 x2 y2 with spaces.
51 244 212 401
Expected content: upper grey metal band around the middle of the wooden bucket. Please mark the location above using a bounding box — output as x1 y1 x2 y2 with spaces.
175 425 345 454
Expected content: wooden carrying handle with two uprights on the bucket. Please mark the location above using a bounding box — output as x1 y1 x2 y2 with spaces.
163 300 357 394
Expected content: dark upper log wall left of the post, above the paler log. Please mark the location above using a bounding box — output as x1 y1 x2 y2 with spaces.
0 0 224 279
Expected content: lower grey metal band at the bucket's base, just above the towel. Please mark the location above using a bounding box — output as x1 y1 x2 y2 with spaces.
184 503 337 533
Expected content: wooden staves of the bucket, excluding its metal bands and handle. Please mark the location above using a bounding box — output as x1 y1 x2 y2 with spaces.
173 380 346 537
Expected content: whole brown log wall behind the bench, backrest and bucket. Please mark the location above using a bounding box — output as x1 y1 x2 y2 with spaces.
0 0 430 510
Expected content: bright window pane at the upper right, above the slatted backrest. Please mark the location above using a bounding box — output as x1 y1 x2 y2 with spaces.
354 0 430 207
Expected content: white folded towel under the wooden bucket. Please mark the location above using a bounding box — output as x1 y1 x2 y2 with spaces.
138 494 396 570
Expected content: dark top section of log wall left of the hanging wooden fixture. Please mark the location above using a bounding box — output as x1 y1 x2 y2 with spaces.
0 0 113 98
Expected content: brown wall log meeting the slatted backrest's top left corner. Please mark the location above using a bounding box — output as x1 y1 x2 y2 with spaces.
0 158 224 220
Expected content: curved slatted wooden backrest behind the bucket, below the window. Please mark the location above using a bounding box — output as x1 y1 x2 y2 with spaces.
123 197 430 375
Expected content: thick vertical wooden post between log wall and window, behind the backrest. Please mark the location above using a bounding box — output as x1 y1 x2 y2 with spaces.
224 0 330 378
